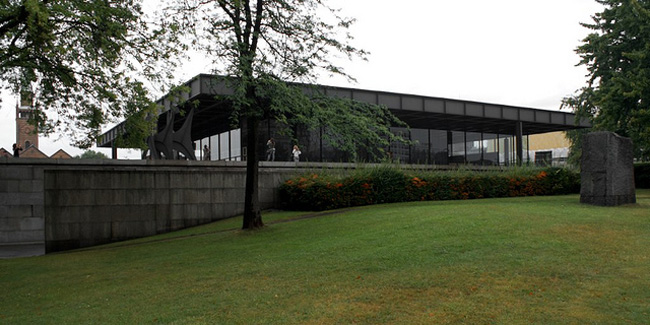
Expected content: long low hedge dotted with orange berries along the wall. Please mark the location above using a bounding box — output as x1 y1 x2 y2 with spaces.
280 167 580 211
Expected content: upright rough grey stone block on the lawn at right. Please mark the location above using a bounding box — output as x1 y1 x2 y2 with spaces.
580 132 636 206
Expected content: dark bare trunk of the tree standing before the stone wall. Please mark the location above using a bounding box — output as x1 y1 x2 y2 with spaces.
242 117 264 229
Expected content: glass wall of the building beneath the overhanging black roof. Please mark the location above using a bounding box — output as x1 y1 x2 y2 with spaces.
191 121 534 166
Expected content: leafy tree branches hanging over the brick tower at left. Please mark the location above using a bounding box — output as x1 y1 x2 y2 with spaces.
0 0 181 147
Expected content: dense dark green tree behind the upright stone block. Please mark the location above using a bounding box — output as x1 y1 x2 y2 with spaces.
563 0 650 160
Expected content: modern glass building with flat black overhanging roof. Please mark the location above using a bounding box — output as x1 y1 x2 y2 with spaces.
98 74 590 165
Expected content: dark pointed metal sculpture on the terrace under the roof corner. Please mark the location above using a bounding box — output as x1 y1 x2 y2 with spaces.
142 108 196 160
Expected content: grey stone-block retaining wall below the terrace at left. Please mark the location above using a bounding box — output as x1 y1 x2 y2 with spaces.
0 158 306 257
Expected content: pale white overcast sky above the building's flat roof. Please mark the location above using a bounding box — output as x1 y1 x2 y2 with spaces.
0 0 603 158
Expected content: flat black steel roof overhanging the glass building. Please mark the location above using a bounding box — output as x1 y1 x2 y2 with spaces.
97 74 591 147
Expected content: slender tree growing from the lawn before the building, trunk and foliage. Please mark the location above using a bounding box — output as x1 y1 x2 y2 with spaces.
168 0 404 229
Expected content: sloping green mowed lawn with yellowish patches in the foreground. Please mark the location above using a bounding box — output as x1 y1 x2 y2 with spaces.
0 190 650 324
